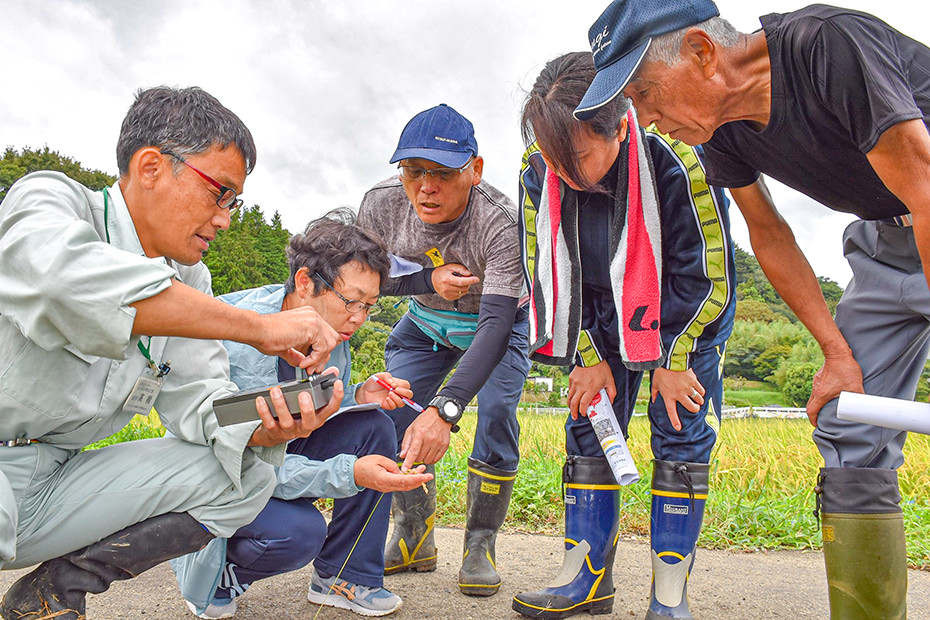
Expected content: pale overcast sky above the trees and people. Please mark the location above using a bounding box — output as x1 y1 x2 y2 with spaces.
7 0 930 286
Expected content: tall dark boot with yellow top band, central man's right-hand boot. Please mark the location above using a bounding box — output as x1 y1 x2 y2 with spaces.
459 458 517 596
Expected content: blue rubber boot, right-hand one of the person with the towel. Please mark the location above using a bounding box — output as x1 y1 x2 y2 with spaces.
646 459 710 620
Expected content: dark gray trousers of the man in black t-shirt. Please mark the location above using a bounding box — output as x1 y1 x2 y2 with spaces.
814 220 930 469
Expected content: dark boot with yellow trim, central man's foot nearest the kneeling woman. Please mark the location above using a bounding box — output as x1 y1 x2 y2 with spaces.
384 465 436 575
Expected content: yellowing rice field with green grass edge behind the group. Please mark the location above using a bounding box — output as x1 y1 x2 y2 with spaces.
436 413 930 570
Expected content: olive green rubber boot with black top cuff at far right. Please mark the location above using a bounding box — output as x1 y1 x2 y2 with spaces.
815 467 907 620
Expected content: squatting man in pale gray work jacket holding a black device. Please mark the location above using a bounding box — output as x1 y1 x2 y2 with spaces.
0 88 343 620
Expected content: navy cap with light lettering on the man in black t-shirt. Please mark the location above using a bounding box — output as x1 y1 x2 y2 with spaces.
575 0 720 121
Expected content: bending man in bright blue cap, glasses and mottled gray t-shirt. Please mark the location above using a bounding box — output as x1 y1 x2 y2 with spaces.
358 104 530 596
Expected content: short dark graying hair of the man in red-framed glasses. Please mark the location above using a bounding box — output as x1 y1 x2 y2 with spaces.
116 86 256 175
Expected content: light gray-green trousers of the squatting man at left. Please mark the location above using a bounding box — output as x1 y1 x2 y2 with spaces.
0 437 275 569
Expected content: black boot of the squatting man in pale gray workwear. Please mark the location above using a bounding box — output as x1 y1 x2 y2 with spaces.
0 512 213 620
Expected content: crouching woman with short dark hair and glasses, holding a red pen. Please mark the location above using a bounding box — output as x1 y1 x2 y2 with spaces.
173 209 431 618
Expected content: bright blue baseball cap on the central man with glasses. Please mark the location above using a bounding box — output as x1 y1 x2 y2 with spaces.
390 103 478 168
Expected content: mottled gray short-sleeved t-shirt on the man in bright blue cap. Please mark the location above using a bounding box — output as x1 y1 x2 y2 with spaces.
358 176 524 314
